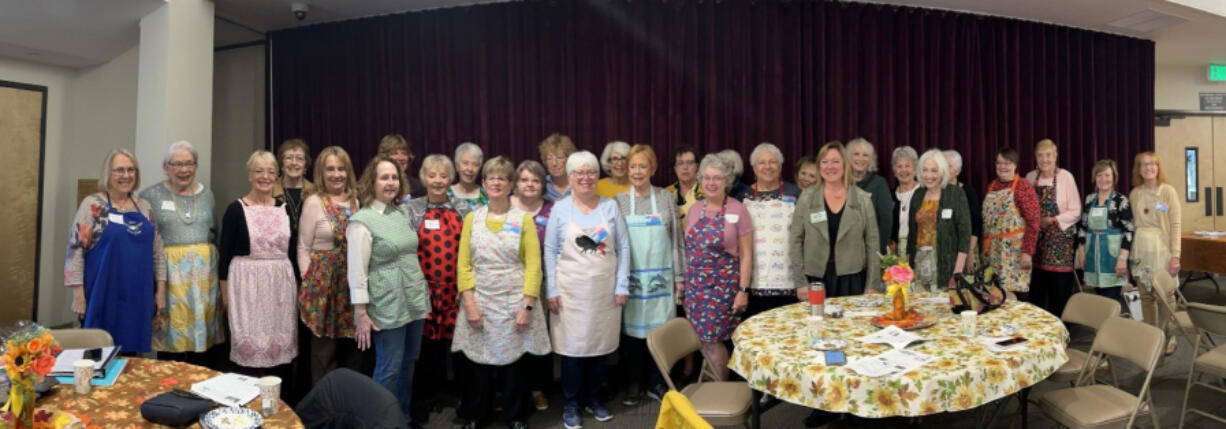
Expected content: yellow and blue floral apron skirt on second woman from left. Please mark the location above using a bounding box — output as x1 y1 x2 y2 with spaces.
153 243 226 353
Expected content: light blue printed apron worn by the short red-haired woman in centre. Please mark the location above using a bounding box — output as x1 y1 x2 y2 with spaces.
622 188 677 338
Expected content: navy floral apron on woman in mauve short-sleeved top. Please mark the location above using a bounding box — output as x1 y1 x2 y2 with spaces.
684 204 741 343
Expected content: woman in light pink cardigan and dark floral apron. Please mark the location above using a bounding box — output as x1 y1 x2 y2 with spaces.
1026 139 1081 315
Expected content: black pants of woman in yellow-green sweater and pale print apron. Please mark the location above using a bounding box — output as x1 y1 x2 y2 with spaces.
456 358 526 423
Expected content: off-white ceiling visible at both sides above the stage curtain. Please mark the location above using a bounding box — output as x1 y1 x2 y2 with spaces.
0 0 1226 67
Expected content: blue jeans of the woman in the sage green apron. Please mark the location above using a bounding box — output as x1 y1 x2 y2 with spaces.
371 319 425 422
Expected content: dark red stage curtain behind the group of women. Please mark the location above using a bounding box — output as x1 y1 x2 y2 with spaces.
270 0 1154 189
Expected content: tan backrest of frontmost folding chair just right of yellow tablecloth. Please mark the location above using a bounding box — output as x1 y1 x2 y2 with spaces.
1087 317 1166 371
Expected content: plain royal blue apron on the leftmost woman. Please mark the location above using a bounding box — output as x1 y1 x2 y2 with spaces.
83 195 154 352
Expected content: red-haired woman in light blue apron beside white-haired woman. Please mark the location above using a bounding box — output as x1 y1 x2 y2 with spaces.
617 145 685 406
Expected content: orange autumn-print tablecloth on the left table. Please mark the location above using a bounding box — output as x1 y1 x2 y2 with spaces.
37 358 303 429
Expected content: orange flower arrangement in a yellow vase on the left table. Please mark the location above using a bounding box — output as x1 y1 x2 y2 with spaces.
0 324 63 428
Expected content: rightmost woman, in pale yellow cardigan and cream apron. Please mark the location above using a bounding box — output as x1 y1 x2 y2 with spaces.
1128 152 1183 354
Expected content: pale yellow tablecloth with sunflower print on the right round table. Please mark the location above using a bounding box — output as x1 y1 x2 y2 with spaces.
728 295 1068 418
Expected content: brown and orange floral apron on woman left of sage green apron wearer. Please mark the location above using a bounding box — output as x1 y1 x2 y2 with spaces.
298 197 353 338
